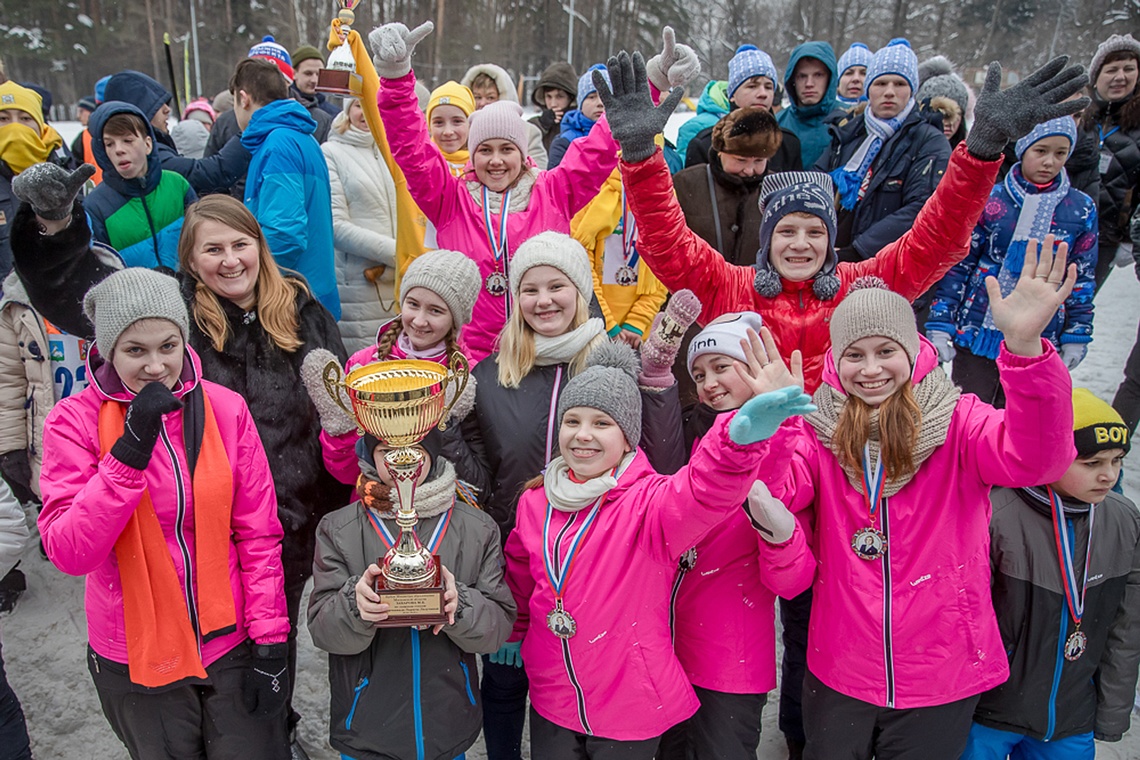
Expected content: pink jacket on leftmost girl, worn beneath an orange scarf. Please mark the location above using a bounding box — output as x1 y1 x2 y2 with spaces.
39 346 290 665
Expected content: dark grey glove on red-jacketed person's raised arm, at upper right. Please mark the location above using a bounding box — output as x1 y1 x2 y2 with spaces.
966 56 1090 161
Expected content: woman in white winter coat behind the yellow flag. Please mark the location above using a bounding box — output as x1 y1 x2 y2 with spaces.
320 98 398 354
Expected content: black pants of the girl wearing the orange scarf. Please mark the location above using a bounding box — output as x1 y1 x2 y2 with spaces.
87 641 290 760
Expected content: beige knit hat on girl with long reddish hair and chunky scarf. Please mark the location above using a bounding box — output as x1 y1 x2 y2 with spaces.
831 277 919 366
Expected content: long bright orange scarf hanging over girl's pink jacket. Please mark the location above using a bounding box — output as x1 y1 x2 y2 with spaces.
99 390 237 687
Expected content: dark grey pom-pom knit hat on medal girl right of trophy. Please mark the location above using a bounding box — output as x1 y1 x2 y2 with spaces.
557 341 641 447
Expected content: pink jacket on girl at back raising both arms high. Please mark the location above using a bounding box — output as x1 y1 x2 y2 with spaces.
376 73 618 363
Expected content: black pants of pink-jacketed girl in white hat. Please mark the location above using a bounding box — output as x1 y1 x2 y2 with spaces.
657 686 768 760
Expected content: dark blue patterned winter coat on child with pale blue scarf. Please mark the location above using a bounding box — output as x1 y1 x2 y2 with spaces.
926 164 1098 349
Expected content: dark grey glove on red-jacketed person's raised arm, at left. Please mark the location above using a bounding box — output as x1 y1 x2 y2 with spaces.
593 50 684 164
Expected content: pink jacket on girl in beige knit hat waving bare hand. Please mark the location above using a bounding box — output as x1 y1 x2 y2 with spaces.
759 338 1076 709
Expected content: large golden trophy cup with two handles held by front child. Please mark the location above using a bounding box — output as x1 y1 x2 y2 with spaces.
324 353 470 628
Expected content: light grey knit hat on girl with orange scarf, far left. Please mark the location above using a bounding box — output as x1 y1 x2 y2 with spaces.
83 267 190 360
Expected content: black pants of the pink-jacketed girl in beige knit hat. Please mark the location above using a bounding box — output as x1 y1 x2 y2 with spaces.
804 672 982 760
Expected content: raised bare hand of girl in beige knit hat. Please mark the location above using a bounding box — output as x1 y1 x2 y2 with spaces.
986 235 1076 357
